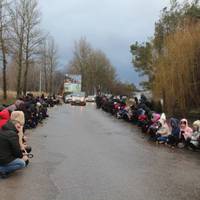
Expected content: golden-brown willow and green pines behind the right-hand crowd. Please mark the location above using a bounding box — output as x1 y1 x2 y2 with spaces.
131 0 200 115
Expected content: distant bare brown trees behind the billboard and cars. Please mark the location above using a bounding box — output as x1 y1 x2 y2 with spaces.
68 38 136 96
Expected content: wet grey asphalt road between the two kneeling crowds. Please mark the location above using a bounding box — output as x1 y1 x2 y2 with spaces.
0 104 200 200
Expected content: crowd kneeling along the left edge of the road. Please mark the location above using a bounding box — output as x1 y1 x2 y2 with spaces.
0 93 60 178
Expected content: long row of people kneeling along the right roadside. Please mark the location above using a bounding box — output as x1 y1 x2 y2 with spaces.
96 95 200 151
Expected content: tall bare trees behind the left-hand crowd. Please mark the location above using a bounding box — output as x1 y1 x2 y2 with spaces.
0 0 64 99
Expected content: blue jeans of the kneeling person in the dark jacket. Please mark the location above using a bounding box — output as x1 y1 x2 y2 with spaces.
0 158 26 173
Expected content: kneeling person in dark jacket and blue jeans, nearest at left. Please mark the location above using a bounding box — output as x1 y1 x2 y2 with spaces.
0 120 28 178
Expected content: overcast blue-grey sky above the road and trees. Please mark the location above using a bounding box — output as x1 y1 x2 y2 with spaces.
39 0 169 84
